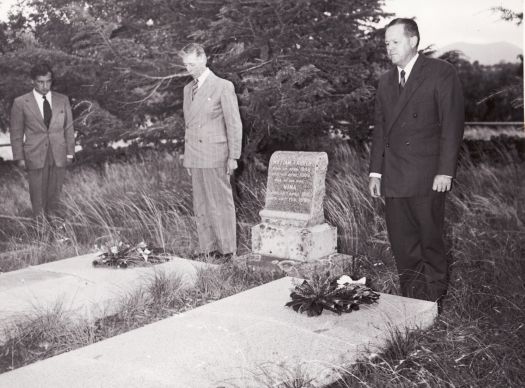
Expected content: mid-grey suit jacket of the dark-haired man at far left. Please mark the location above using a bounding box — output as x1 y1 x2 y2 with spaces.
10 91 75 170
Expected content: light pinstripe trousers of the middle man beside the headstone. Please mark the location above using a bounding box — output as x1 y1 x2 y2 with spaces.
190 167 237 254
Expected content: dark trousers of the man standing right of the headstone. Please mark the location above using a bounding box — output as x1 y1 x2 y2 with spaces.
386 191 448 301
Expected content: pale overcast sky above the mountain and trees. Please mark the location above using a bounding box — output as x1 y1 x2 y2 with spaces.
0 0 524 48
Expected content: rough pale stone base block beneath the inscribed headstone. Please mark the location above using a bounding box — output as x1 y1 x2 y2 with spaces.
252 222 337 261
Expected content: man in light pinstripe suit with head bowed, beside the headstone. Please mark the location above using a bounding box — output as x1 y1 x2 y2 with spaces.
180 43 242 259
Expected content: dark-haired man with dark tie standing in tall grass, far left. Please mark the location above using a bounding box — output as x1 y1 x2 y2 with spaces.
10 63 75 218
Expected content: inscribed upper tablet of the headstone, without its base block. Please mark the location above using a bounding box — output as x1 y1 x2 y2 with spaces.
260 151 328 227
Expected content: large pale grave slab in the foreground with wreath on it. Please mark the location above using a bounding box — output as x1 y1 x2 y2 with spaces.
0 277 437 388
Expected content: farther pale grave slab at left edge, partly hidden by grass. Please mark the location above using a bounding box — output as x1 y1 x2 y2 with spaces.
0 254 211 341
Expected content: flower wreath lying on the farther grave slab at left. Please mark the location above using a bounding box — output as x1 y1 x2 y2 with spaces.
93 241 170 268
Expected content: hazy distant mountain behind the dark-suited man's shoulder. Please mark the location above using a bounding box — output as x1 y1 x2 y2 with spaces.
436 42 523 65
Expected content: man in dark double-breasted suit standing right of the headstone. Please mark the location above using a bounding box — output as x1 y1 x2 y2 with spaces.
369 19 464 302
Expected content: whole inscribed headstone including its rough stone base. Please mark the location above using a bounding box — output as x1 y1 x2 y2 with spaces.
252 151 337 261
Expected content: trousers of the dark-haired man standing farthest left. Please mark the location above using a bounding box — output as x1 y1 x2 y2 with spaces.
27 147 66 218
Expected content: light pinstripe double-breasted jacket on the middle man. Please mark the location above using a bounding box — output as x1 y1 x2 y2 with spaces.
183 72 242 168
